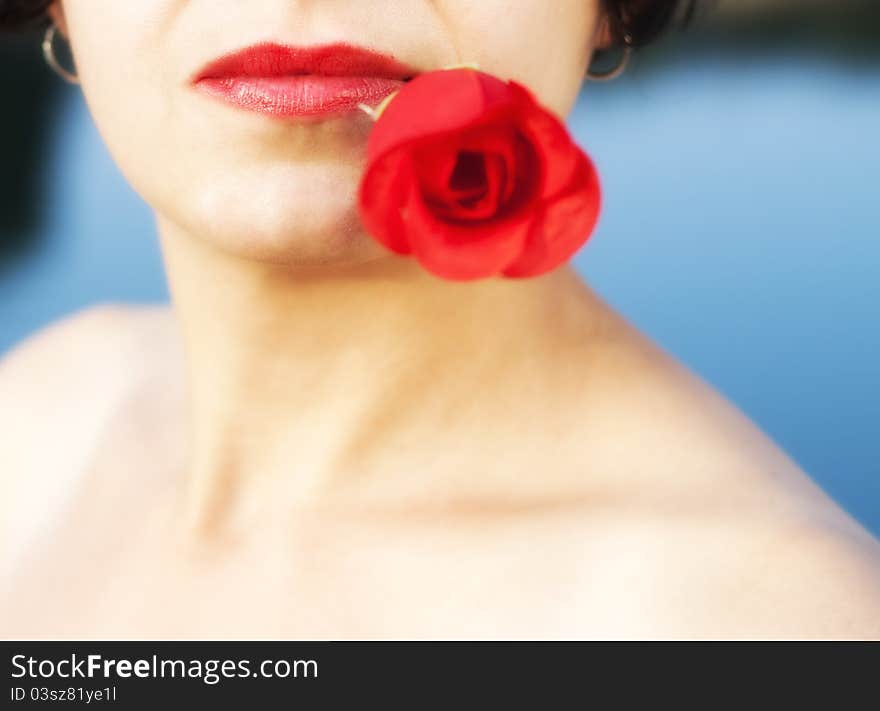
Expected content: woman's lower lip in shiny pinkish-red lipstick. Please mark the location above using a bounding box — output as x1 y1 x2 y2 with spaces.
196 74 403 118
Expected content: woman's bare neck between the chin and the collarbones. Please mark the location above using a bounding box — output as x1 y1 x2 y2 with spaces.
158 219 600 536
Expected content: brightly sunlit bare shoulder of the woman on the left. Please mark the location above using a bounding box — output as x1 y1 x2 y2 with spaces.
0 303 179 556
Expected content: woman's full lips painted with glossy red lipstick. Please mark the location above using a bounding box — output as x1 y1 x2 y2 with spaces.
192 42 416 118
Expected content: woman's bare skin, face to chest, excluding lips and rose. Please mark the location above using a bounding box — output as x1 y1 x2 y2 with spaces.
0 0 880 639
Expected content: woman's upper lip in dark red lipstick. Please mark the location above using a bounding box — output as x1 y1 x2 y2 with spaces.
192 42 417 83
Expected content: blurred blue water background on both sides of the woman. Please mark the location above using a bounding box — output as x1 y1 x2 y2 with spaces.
0 0 880 535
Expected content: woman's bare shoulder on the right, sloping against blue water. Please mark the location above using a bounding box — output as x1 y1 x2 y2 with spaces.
556 308 880 639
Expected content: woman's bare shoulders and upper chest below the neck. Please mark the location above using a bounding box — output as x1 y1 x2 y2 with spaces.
0 258 880 639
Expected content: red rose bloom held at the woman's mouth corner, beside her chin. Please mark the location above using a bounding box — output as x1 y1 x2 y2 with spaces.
359 69 600 280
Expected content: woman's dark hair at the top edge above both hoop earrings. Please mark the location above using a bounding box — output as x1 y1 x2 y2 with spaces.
0 0 696 47
